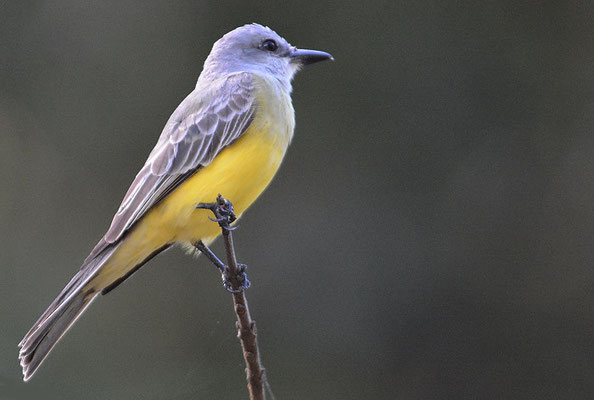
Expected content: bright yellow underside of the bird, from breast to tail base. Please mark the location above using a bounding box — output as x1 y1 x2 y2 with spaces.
92 122 288 289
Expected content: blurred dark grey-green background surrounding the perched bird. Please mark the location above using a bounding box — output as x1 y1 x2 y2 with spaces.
0 0 594 400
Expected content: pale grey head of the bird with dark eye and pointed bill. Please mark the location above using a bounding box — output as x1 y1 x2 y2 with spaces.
201 24 333 84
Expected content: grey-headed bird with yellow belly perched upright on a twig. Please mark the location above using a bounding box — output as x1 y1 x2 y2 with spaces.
19 23 333 381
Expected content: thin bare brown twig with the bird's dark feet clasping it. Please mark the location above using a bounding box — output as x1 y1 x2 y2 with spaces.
195 194 265 400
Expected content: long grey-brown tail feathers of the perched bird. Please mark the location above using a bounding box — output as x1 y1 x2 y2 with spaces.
19 246 117 381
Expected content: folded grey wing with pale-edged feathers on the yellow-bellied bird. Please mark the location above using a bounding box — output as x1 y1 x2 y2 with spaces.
99 73 256 247
